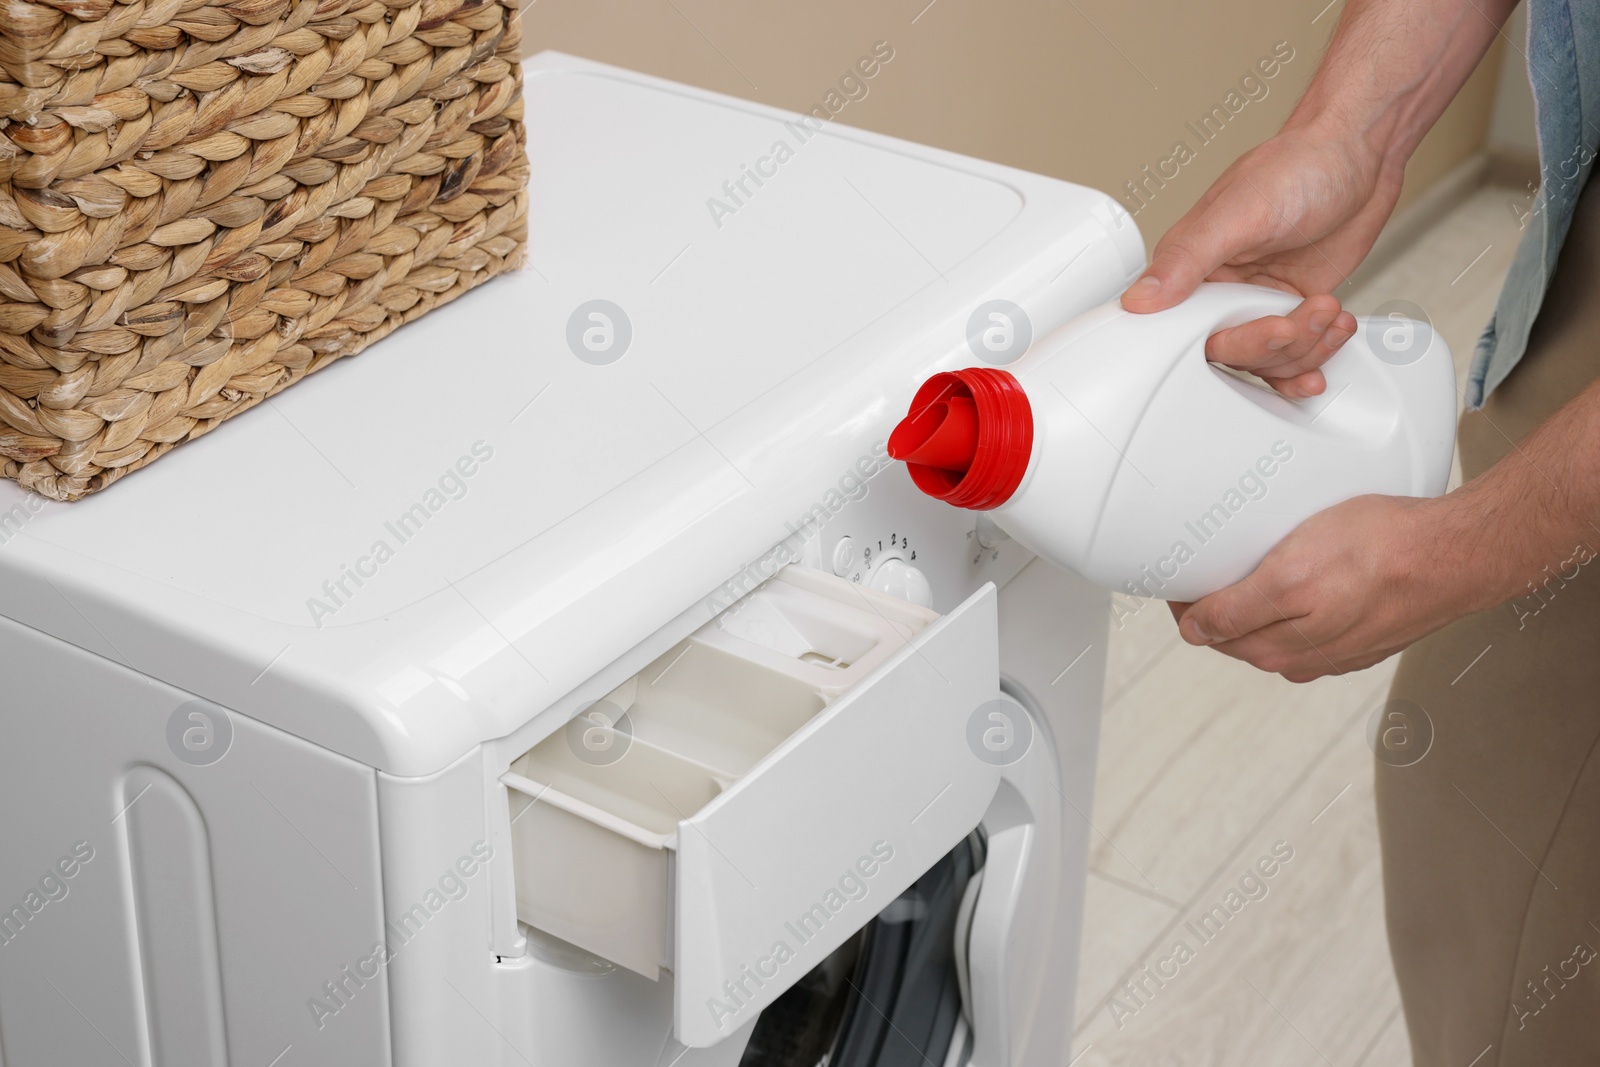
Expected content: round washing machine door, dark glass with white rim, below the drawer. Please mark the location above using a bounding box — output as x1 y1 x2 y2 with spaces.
741 683 1077 1067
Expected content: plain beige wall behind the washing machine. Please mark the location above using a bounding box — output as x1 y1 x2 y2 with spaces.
523 0 1499 254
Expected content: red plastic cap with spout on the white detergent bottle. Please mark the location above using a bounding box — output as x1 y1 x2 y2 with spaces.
890 366 1034 512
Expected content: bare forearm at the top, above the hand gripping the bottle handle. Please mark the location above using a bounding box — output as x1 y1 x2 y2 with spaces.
1286 0 1515 166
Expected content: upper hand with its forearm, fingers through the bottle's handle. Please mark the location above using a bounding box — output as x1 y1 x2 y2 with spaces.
1122 0 1515 397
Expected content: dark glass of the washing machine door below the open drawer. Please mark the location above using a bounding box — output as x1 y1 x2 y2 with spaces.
739 832 984 1067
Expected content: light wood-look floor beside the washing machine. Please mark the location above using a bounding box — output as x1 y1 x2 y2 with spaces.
1074 187 1520 1067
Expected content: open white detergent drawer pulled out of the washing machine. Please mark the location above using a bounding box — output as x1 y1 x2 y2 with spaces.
502 566 1000 1046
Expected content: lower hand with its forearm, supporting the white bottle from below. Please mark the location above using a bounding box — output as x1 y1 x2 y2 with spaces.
1171 363 1600 681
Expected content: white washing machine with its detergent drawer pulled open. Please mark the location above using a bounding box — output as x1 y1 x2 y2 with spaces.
0 53 1142 1067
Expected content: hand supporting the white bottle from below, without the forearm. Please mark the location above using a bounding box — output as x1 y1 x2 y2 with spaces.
1171 496 1472 681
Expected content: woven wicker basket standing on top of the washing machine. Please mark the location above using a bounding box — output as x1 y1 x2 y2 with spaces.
0 0 528 501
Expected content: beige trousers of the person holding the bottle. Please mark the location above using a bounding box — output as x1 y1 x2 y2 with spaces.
1378 184 1600 1067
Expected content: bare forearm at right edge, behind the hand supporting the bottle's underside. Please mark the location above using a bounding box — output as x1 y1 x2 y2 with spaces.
1419 382 1600 613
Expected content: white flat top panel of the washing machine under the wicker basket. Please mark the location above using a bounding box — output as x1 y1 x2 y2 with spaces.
0 53 1144 776
